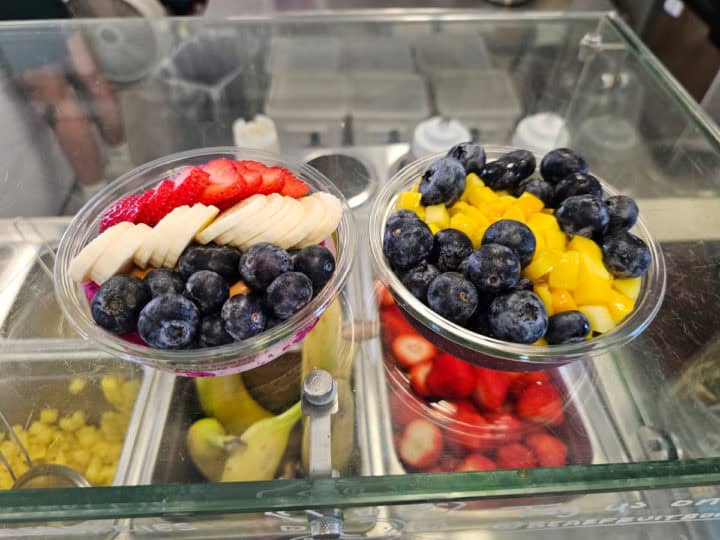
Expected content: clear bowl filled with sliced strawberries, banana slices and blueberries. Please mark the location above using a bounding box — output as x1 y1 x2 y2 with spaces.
54 147 355 376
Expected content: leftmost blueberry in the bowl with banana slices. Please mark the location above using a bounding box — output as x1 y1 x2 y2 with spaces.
90 275 152 334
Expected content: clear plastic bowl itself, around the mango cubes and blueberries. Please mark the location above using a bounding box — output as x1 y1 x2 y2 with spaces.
369 145 666 371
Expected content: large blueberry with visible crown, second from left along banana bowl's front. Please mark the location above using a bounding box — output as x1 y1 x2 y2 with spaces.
138 294 200 349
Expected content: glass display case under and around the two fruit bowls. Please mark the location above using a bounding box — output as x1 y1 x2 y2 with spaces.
0 10 720 539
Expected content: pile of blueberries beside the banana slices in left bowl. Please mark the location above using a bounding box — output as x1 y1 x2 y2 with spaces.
90 243 335 349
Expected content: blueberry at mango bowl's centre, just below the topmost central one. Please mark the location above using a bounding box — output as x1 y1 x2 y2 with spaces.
465 244 520 294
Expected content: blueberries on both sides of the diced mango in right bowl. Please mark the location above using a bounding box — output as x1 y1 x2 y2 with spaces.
383 143 651 345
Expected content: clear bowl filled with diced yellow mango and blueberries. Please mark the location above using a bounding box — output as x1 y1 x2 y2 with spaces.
370 143 666 371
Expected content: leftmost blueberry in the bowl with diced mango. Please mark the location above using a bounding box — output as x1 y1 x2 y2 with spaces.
383 219 433 269
